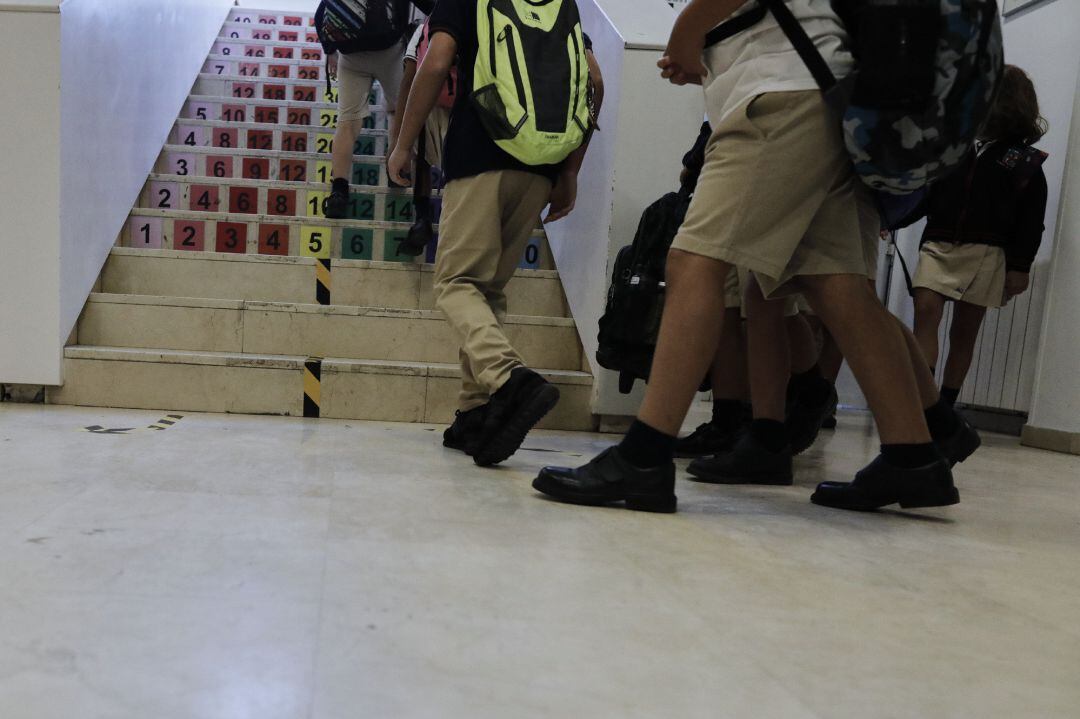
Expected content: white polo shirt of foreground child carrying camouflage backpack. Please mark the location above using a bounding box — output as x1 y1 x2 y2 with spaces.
702 0 854 127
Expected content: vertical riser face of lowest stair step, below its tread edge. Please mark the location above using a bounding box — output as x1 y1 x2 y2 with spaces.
46 360 595 427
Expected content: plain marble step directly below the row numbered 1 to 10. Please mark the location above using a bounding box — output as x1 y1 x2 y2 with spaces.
100 247 570 317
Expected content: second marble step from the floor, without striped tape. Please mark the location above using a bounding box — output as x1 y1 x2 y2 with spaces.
78 293 582 370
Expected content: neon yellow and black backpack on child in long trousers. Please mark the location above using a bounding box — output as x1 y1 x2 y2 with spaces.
470 0 590 165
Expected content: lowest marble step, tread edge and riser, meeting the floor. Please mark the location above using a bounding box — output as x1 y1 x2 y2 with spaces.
45 345 596 427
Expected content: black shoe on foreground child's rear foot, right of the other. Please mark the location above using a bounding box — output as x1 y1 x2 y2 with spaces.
810 456 960 512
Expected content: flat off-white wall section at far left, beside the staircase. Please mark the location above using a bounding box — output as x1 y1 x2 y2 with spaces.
0 7 60 383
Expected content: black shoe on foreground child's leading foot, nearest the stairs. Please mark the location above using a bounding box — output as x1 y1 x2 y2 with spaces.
532 447 677 512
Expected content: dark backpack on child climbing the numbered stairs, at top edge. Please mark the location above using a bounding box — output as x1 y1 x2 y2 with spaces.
315 0 409 54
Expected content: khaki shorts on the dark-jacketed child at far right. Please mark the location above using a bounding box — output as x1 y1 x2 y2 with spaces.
912 242 1008 308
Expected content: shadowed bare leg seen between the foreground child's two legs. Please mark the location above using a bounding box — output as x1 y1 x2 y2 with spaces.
745 274 792 422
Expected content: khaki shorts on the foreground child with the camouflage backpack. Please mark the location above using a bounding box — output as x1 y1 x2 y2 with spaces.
672 91 878 297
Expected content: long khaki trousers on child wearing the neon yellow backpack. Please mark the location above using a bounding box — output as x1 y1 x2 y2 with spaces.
434 169 552 411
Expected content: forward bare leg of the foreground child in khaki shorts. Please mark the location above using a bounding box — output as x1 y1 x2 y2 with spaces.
637 249 731 437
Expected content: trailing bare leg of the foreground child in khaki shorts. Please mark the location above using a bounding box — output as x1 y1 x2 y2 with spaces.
799 274 930 445
